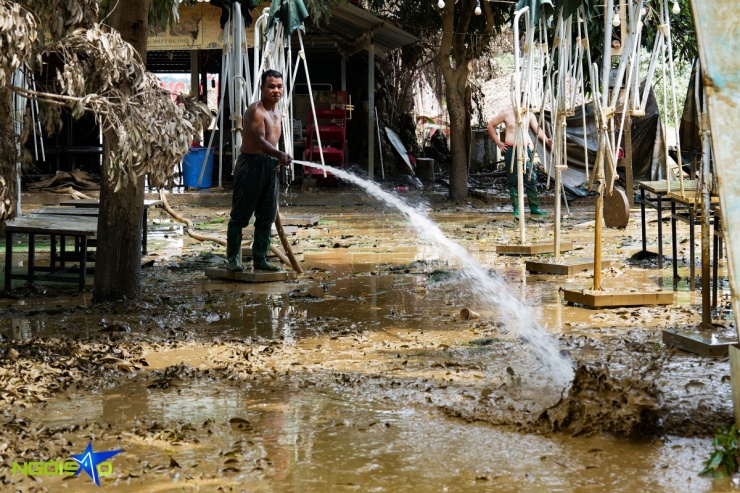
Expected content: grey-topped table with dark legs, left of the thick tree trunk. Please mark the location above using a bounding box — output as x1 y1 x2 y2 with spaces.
5 214 98 291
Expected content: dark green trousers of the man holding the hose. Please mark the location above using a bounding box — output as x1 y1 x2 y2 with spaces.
228 154 280 259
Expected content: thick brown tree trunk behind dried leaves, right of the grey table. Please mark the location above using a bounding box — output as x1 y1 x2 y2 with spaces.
94 0 149 302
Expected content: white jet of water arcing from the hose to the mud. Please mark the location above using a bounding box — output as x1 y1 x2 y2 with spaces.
293 160 573 385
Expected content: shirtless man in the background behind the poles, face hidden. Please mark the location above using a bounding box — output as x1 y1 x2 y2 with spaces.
488 108 552 217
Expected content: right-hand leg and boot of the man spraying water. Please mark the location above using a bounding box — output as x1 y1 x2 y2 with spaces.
252 156 282 272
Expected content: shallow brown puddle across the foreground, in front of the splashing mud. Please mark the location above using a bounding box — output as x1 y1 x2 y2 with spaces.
10 374 710 492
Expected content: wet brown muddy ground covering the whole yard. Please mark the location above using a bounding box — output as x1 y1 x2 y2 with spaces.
0 179 735 492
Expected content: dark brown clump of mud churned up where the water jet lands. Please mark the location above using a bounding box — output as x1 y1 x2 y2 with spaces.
537 363 662 436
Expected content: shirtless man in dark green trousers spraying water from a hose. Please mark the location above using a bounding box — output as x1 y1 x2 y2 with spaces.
226 70 293 272
